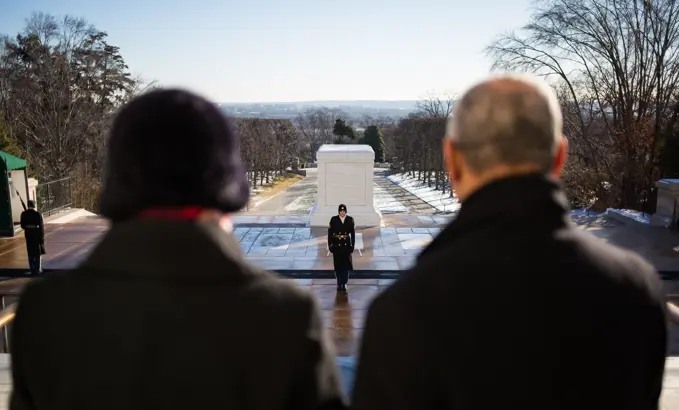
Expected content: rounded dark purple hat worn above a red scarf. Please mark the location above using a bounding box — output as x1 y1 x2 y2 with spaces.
99 89 249 222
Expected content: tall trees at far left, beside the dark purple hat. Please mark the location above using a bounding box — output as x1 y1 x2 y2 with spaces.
0 13 136 209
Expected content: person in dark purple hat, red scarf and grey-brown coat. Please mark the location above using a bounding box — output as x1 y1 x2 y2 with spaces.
10 90 344 410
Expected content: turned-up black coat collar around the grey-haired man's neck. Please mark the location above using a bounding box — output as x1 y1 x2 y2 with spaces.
418 174 569 260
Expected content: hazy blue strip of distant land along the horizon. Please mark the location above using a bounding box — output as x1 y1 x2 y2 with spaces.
218 100 417 119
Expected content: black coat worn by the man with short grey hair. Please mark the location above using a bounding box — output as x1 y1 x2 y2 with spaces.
353 175 667 410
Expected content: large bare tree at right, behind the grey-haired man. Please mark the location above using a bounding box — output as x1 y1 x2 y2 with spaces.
487 0 679 209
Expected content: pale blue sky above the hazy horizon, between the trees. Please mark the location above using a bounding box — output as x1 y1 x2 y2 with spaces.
0 0 530 102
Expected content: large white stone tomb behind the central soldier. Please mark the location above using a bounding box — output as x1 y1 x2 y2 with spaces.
309 144 382 227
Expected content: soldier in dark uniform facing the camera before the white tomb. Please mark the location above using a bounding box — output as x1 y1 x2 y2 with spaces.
328 204 356 292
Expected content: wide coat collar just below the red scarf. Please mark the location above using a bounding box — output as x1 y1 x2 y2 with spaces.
81 219 245 279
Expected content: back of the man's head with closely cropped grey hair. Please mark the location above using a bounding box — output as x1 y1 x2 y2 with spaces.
446 75 563 173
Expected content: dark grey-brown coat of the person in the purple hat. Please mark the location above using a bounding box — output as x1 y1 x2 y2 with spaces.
6 220 343 410
